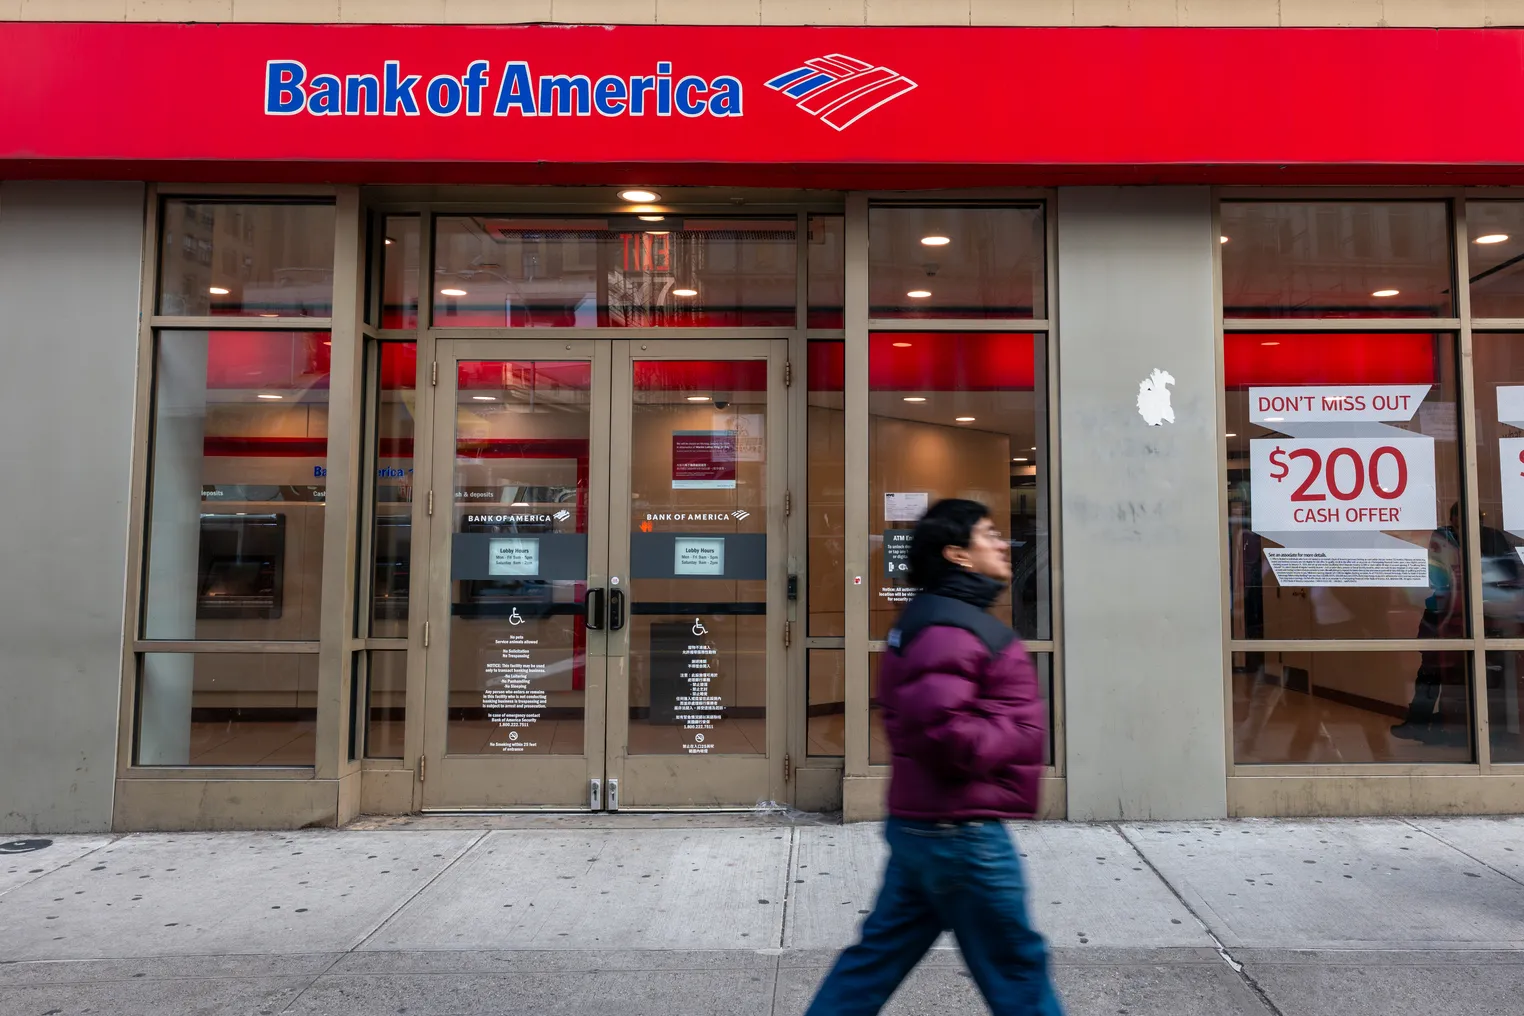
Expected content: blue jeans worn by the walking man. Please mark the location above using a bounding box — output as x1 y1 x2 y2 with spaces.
806 818 1064 1016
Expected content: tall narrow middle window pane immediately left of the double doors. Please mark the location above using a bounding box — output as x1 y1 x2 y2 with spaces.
370 343 418 638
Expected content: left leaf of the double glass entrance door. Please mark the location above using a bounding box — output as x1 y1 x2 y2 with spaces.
424 340 610 809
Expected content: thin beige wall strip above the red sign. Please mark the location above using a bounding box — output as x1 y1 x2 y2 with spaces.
17 0 1524 27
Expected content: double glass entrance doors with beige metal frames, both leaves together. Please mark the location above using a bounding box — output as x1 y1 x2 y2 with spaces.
422 340 788 810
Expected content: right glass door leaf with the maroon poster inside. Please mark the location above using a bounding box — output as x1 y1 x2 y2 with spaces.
607 340 788 807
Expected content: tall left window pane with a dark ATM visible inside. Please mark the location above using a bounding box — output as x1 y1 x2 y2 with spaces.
143 331 331 640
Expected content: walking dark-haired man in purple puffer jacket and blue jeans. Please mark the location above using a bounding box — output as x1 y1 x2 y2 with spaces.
806 500 1062 1016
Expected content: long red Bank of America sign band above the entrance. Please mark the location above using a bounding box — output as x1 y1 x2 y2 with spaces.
0 23 1524 186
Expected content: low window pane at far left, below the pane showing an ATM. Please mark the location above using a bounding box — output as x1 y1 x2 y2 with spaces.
137 652 317 766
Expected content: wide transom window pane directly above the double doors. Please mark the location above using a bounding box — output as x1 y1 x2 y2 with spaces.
433 215 799 327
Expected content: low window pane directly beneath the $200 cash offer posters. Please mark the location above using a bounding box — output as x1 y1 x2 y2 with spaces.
1233 650 1472 765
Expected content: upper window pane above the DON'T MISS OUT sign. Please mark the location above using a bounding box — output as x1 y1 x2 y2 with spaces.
1221 201 1455 317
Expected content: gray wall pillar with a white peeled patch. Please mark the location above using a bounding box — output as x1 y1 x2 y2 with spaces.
1056 187 1227 821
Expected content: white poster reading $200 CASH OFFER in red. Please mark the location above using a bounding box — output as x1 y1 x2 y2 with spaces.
1248 436 1436 533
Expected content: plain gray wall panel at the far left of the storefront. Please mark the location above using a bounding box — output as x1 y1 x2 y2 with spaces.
0 183 143 833
